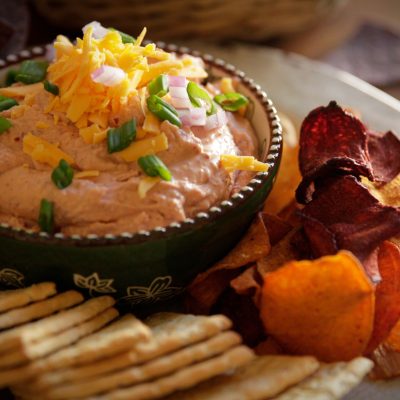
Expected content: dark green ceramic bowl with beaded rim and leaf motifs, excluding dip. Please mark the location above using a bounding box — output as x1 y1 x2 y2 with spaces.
0 43 282 306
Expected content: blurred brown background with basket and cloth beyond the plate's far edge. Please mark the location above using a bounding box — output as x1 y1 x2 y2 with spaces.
0 0 400 99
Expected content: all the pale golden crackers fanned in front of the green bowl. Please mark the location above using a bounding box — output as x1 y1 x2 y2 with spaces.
0 283 371 400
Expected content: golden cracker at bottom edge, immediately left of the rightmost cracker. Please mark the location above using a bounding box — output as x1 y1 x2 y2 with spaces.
168 356 319 400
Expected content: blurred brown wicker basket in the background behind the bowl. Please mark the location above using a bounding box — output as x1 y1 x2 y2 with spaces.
35 0 344 42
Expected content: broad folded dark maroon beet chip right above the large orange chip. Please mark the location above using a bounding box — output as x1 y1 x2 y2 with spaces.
300 175 400 262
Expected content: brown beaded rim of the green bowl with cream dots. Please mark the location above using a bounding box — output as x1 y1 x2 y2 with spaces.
0 42 283 247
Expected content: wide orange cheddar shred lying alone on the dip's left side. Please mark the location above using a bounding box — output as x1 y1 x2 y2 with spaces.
22 132 74 168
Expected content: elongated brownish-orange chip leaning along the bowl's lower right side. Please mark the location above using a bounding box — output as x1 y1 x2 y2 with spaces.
186 213 271 314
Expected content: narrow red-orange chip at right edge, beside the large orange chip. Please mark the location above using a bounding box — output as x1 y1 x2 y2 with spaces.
366 241 400 354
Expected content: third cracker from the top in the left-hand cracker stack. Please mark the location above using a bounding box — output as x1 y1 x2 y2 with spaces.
0 291 115 354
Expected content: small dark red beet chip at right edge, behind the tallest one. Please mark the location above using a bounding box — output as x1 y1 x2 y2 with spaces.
367 131 400 184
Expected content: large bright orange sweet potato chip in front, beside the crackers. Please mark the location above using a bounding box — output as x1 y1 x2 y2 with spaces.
261 251 375 362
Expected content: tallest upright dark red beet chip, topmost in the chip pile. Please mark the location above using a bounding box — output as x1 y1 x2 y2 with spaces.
296 101 373 203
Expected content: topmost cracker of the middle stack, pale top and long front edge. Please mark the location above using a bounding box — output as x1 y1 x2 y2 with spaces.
17 313 232 384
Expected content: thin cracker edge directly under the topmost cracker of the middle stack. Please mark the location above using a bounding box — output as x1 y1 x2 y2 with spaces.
24 331 241 400
